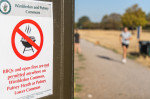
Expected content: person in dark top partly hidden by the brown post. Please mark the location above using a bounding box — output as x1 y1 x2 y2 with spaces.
74 29 81 54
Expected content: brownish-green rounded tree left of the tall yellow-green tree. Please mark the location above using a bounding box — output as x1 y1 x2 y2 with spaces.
101 13 122 29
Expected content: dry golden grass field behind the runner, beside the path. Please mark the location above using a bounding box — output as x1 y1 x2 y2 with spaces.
79 30 150 66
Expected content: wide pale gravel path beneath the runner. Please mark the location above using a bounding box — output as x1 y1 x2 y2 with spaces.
75 40 150 99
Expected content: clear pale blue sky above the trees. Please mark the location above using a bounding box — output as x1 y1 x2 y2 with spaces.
75 0 150 22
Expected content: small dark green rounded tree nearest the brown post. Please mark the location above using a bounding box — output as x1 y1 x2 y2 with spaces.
77 16 91 28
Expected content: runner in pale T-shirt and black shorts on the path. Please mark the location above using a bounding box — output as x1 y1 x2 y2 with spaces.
120 27 132 63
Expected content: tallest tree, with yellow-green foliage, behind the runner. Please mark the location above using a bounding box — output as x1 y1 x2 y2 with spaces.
122 4 147 28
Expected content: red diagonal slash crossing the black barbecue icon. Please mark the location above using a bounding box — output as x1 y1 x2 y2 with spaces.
17 29 40 50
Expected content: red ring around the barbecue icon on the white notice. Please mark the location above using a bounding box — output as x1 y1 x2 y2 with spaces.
11 19 43 61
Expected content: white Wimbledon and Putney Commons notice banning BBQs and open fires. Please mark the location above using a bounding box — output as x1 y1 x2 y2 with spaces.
0 0 53 99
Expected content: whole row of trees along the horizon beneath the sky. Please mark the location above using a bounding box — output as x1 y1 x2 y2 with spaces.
75 4 150 29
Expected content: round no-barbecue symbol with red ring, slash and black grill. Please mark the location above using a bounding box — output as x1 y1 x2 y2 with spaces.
11 19 43 61
